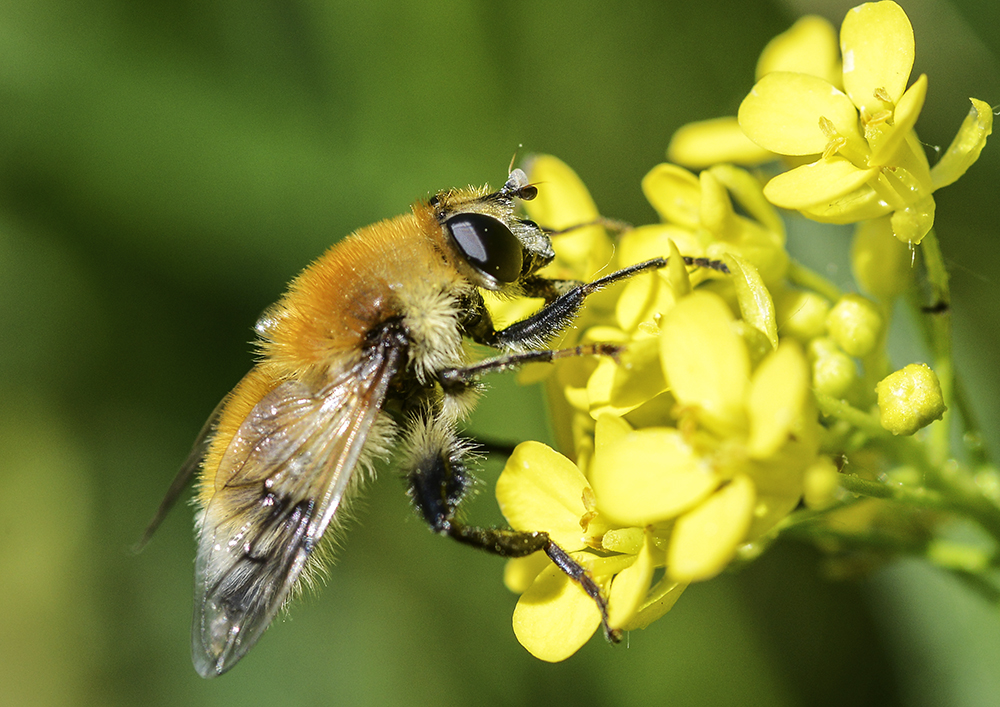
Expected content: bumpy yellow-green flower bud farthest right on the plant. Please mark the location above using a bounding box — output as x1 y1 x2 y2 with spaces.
875 363 947 435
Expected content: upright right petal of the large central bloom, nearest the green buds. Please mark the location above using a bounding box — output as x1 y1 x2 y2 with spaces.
747 340 809 459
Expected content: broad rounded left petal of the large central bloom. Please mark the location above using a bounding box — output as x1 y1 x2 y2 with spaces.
591 427 719 527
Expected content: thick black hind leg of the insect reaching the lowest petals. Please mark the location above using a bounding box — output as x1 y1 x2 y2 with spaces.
396 412 621 643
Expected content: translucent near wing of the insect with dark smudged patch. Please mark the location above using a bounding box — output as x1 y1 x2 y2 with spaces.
192 337 406 677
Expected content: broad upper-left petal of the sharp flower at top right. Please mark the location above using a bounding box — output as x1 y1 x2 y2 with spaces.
739 72 861 155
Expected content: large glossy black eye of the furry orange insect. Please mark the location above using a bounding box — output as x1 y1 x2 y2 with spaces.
444 213 523 287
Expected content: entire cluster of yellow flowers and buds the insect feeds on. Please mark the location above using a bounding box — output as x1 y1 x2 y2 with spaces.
494 0 988 661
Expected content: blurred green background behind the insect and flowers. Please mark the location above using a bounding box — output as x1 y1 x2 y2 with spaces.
0 0 1000 707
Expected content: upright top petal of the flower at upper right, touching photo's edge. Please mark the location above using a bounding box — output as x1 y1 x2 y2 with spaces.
840 0 913 114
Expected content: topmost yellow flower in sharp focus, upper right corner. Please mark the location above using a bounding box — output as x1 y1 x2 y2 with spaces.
739 0 993 243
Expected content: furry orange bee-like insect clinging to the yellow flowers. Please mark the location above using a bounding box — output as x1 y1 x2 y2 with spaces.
147 169 724 677
